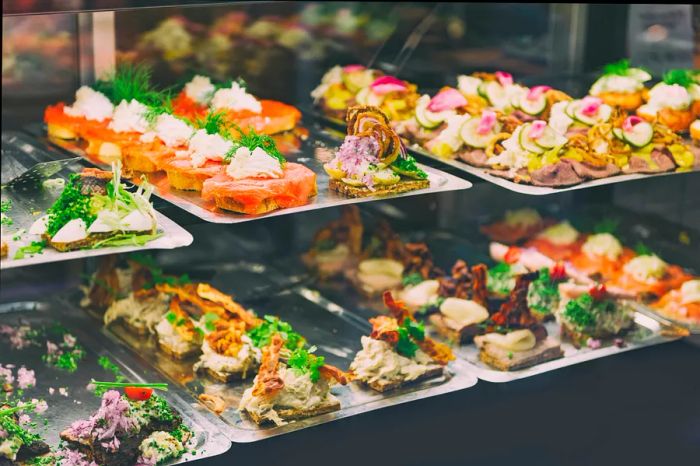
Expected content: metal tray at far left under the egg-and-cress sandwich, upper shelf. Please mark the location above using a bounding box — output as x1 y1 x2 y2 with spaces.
0 134 194 270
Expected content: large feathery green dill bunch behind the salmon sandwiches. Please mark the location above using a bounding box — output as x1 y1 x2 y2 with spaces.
94 63 163 107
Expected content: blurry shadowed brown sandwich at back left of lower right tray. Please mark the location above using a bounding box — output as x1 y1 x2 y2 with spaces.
302 205 364 280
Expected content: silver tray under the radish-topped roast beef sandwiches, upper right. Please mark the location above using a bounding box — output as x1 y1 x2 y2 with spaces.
311 110 698 196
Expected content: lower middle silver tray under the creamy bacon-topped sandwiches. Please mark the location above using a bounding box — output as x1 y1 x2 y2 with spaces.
98 288 477 442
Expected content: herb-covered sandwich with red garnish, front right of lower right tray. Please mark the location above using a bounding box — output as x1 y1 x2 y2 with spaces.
556 283 634 348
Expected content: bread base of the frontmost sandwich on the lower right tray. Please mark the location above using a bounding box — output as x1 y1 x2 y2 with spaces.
479 338 564 371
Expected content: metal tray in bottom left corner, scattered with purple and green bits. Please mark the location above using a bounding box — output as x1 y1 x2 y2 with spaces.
0 300 231 464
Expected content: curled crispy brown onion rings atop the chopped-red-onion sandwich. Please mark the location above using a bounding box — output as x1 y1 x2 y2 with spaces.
346 105 403 165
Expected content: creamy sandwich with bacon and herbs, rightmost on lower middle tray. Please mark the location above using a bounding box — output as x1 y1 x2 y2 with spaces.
350 292 454 392
